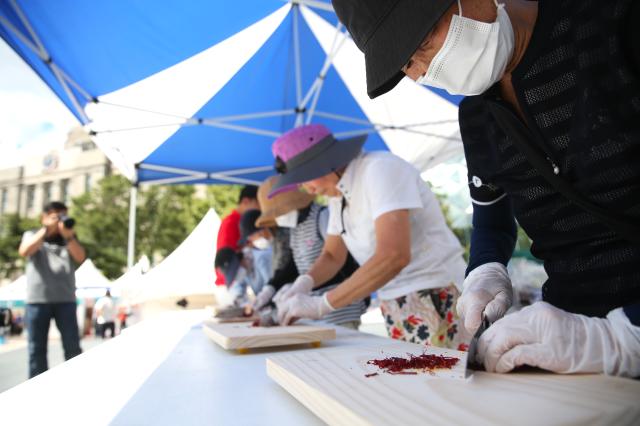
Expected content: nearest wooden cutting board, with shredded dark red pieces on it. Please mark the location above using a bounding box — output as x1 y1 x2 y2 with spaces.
267 343 640 426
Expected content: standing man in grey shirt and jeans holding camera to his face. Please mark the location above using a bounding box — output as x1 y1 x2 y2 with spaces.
18 201 86 378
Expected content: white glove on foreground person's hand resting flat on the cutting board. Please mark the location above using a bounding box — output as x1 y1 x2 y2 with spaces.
477 302 640 377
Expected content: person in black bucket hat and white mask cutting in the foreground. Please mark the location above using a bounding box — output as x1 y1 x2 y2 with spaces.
333 0 640 376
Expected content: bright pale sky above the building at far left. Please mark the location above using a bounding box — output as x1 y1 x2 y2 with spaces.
0 39 78 168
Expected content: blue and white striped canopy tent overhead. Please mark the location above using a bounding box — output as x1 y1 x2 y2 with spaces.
0 0 461 261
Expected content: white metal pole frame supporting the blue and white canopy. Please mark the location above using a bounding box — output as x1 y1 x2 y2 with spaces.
0 0 457 268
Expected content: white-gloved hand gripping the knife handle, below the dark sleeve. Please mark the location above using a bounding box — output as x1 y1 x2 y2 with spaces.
456 262 513 334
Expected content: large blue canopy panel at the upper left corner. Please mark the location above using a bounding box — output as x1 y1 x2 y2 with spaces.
0 0 283 115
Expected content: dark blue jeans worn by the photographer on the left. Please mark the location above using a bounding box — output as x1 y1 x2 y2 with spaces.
25 302 82 378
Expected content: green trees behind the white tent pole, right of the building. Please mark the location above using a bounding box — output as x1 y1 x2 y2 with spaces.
70 175 240 278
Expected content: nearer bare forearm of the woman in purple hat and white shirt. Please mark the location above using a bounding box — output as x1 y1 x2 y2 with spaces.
327 253 411 309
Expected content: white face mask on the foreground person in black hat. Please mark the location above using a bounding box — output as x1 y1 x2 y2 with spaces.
416 0 514 96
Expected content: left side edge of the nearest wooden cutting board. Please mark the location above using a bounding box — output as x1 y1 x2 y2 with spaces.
267 358 371 426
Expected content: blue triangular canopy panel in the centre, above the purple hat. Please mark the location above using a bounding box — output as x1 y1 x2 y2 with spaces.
139 7 387 181
